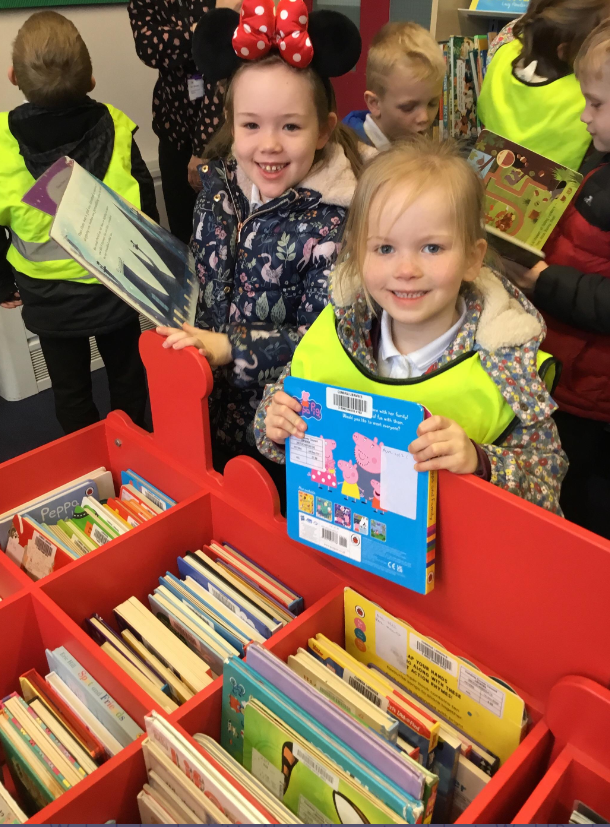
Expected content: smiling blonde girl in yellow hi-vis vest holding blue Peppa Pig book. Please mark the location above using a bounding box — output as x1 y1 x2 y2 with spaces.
255 141 567 513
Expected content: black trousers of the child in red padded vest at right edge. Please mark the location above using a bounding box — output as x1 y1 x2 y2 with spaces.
554 411 610 539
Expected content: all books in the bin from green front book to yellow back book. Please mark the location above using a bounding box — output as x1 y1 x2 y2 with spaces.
209 589 527 824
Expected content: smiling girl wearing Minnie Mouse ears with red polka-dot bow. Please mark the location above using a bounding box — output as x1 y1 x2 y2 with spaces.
159 0 371 494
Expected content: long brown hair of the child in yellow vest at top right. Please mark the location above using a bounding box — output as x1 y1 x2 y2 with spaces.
513 0 610 80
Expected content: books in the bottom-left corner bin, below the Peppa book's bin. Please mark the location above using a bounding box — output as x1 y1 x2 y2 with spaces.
0 646 143 823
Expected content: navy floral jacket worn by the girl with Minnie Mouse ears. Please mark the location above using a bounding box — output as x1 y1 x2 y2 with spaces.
192 144 356 454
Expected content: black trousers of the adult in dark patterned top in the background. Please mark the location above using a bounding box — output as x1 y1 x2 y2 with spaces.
159 138 197 244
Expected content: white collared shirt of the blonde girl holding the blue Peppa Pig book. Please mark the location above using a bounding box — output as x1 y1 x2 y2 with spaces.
377 297 466 379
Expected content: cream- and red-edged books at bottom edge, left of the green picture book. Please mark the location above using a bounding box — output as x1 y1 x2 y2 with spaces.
138 712 300 824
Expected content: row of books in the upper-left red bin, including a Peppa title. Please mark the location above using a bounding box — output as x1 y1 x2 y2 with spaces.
0 468 176 580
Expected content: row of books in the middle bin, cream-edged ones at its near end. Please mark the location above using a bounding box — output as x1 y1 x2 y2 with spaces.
88 541 304 712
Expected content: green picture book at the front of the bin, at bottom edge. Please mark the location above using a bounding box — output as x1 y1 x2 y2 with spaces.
244 701 408 824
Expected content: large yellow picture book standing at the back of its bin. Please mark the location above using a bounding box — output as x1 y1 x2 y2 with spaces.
344 588 526 763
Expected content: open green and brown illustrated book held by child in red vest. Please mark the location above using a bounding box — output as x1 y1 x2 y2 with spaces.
468 129 582 266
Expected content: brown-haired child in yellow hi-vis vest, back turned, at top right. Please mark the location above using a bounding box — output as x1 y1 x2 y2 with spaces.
477 0 610 172
